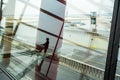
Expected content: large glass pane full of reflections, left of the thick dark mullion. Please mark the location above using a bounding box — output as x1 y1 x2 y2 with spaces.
0 0 116 80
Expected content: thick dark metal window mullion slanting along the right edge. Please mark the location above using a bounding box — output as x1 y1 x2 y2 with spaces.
104 0 120 80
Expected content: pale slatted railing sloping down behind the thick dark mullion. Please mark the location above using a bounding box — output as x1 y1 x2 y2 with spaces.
60 56 120 80
